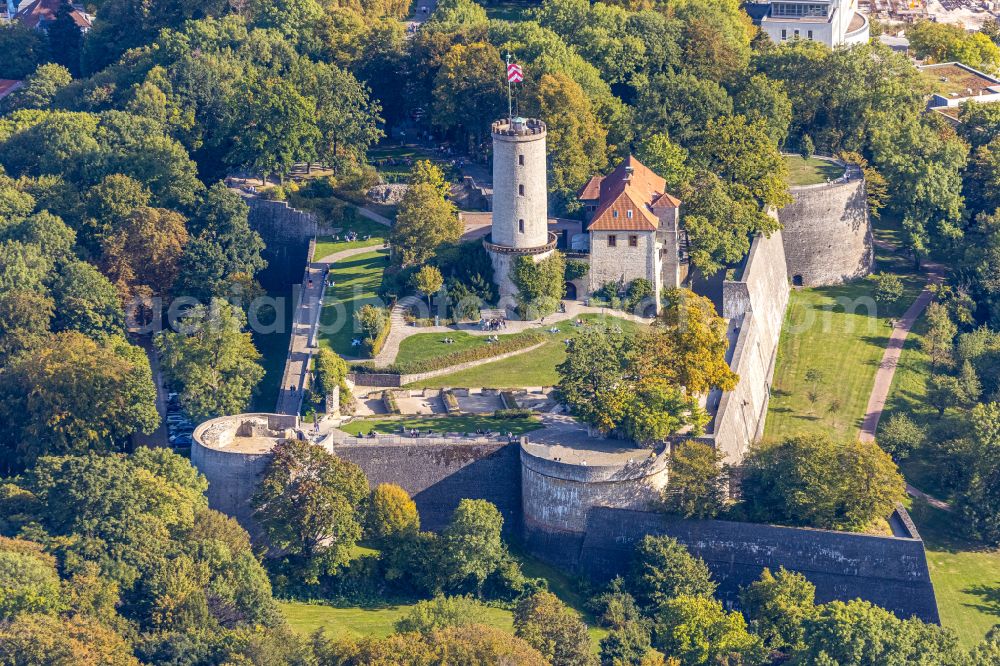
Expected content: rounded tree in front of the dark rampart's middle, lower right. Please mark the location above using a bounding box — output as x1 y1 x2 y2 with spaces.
740 567 816 652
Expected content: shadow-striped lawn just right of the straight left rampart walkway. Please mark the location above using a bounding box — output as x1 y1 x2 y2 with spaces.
319 250 389 357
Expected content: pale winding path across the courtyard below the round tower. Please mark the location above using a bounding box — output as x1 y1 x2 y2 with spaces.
372 296 653 368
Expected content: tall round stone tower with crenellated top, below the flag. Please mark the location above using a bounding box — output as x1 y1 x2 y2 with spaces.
483 118 556 307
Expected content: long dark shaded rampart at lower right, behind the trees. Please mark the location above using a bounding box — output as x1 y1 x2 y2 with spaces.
578 508 940 623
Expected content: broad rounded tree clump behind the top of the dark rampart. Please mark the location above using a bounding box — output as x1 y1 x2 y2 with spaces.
742 435 905 530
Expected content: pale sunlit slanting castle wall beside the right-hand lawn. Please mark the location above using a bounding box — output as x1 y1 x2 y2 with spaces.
704 231 789 464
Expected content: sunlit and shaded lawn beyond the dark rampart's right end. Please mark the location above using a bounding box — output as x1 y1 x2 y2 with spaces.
910 500 1000 647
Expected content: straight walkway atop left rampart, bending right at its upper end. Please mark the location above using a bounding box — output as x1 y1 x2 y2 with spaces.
275 245 388 414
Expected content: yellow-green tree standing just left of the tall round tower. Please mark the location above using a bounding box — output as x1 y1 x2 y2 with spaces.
389 183 462 266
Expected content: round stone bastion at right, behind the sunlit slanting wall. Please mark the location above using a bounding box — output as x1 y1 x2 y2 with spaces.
778 158 875 287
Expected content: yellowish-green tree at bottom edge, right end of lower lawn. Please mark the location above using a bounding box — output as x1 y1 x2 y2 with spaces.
514 591 594 666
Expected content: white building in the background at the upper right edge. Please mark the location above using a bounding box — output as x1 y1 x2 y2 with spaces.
747 0 869 48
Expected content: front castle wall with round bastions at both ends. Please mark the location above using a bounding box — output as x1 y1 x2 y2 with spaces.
191 414 667 544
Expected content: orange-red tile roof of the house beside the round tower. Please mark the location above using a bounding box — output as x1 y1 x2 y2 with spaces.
580 155 681 231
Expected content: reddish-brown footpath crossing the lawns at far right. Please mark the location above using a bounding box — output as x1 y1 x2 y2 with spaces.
859 241 951 511
